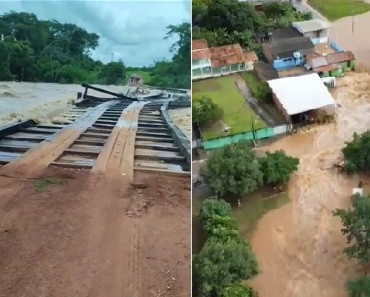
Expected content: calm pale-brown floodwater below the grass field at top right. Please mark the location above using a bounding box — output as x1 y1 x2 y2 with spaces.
331 12 370 67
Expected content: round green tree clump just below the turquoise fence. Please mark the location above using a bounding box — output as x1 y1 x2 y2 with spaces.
202 143 299 197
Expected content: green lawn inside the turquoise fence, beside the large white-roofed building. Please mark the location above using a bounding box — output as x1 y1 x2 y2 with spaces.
193 76 266 140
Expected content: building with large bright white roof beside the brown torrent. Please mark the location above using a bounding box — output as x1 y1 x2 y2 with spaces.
267 73 335 124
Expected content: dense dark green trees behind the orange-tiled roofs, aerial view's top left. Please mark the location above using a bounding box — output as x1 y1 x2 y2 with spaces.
192 0 312 54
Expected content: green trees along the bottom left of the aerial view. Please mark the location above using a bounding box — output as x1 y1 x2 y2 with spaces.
193 198 258 297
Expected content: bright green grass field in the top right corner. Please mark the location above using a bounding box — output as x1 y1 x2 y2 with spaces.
308 0 370 21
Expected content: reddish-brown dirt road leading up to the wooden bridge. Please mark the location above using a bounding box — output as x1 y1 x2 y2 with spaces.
0 170 190 297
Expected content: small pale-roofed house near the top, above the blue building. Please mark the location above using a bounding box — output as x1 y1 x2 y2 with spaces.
292 19 330 45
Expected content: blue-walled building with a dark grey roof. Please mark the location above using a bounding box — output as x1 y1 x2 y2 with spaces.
262 37 315 71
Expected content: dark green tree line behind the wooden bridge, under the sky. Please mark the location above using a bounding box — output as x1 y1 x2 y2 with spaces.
0 12 191 88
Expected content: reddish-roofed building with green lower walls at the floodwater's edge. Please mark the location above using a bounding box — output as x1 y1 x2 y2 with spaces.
305 51 355 77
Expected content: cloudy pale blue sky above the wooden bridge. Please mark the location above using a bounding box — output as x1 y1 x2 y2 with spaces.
0 0 191 66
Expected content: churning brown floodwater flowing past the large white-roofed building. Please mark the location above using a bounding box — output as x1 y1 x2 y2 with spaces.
251 73 370 297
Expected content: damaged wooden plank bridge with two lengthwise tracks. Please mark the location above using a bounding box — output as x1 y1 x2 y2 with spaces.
0 84 190 178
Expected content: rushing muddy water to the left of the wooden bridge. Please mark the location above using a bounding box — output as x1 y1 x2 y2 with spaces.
0 82 134 125
